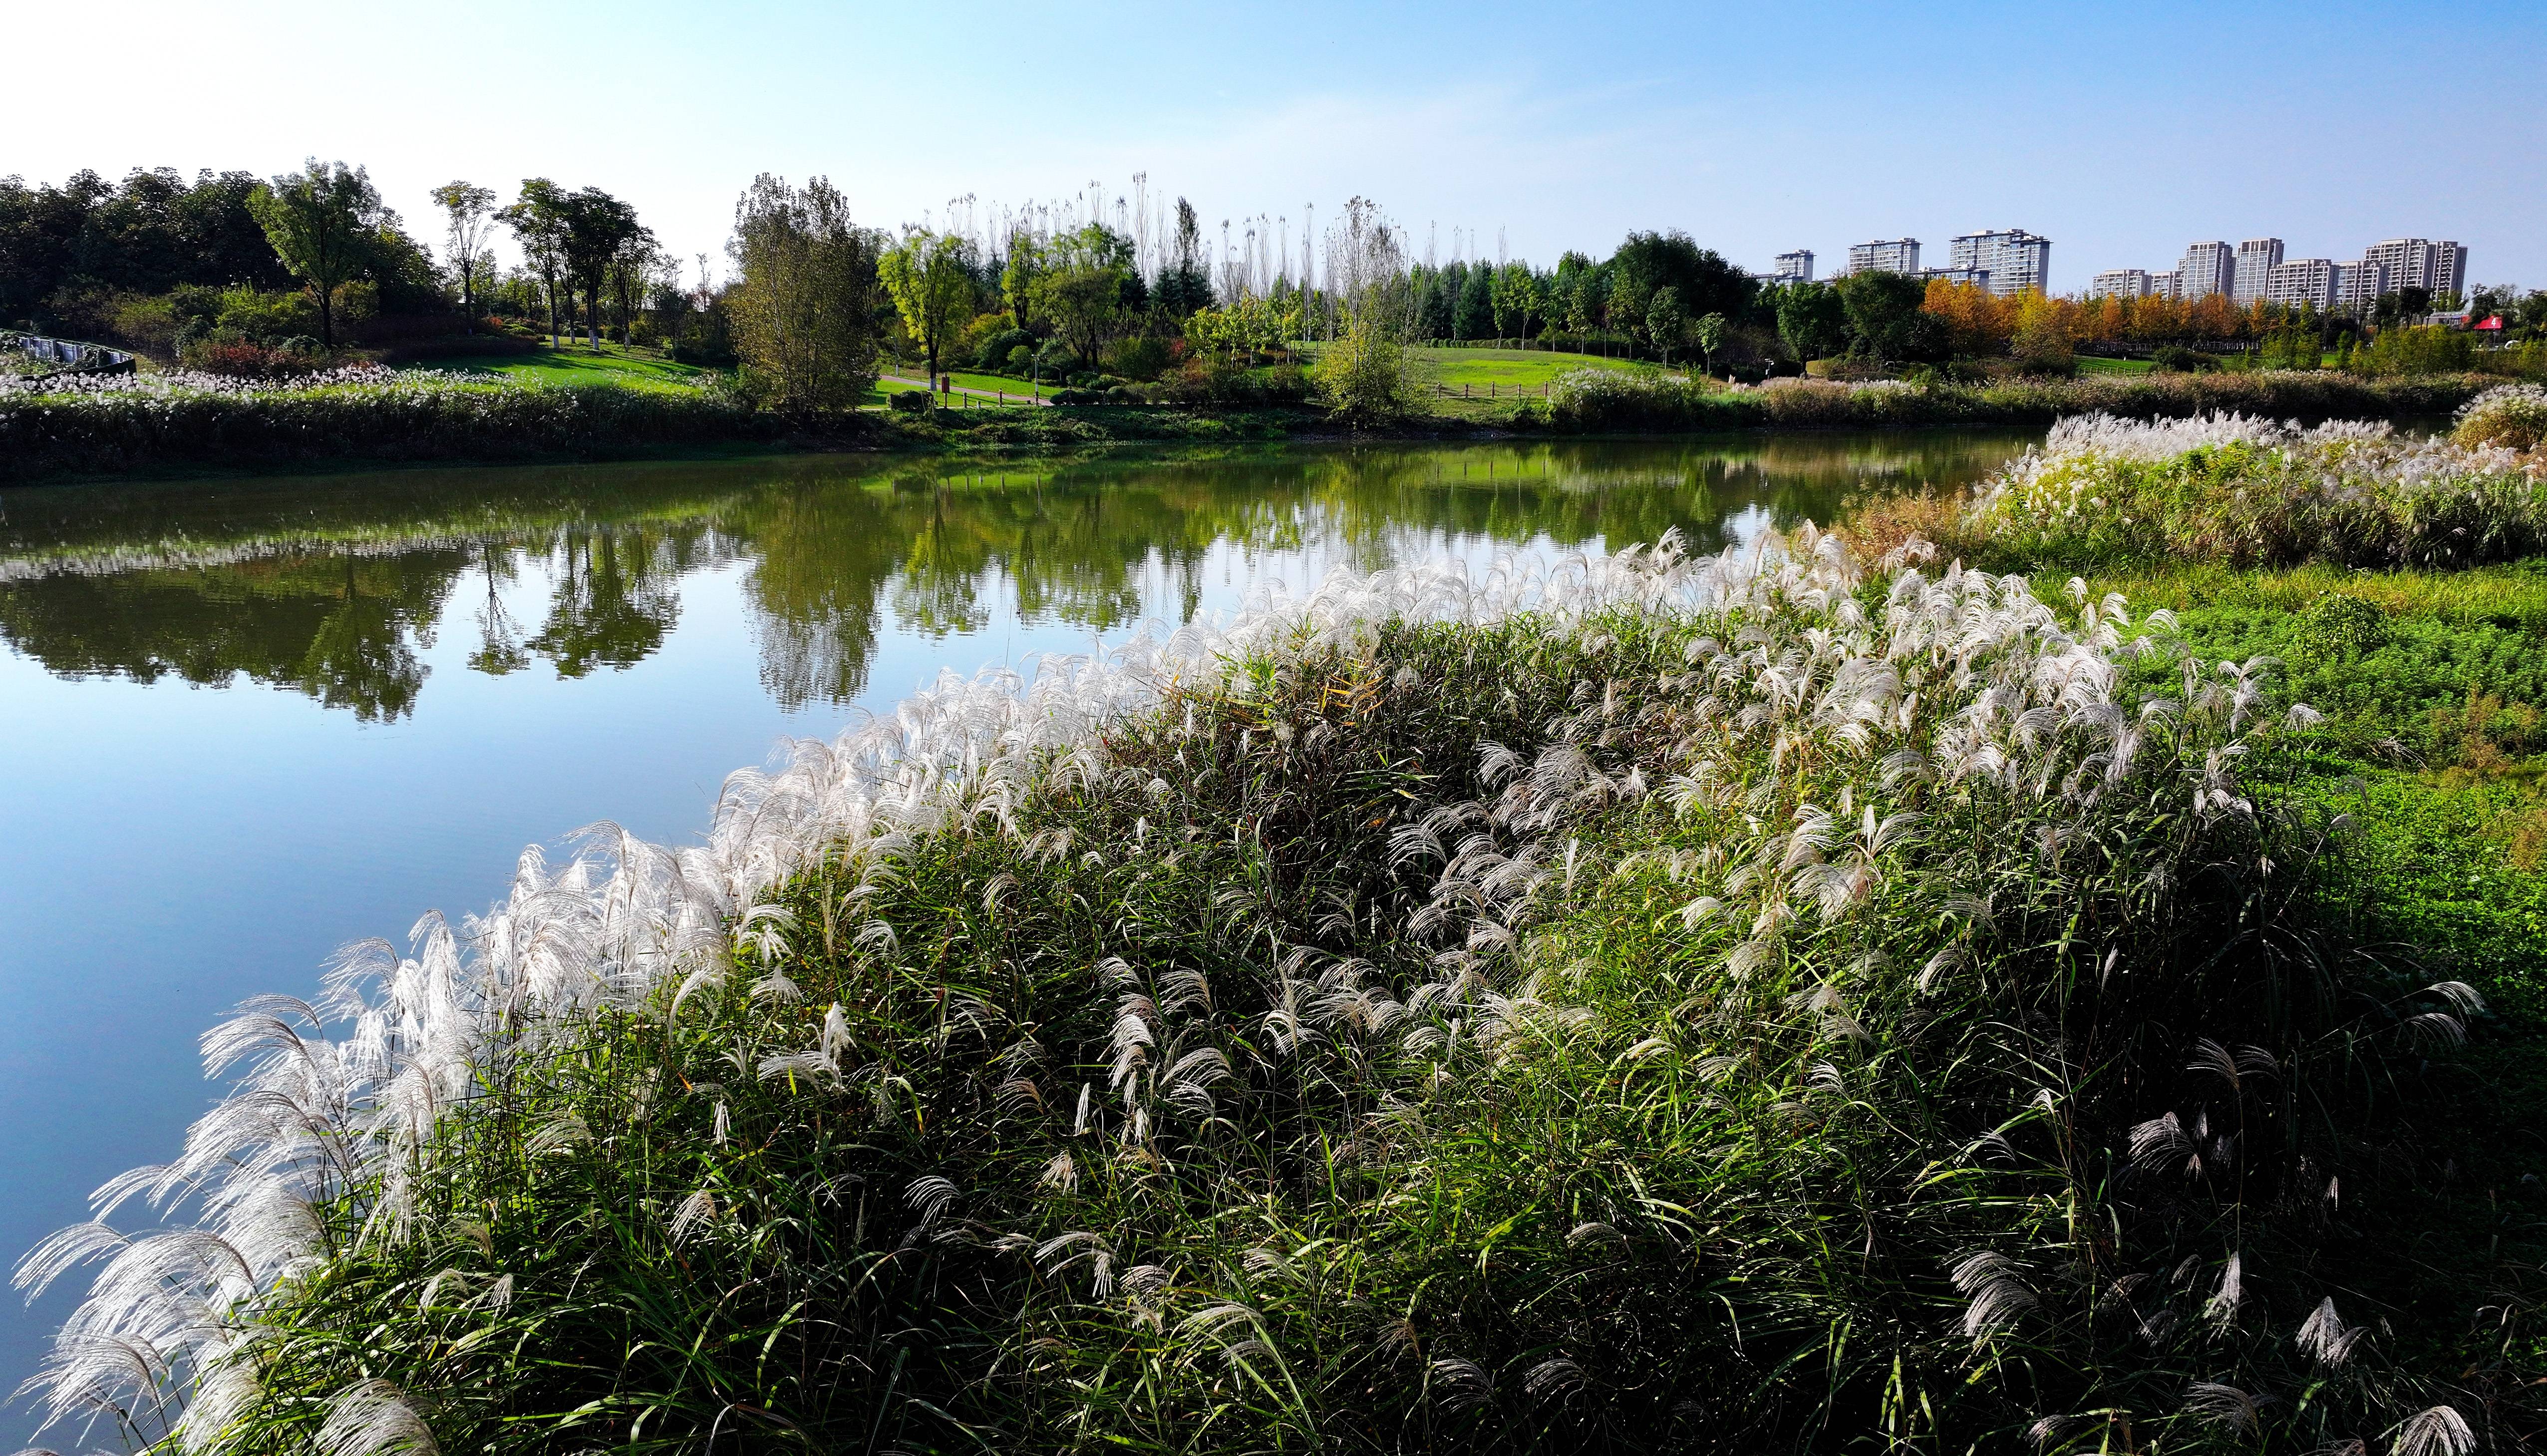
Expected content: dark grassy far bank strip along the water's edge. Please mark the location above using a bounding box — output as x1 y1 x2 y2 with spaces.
0 374 2499 484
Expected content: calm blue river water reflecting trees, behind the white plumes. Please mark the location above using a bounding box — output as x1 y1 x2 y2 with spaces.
0 433 2025 1451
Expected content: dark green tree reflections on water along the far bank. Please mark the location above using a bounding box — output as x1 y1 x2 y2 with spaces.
0 433 2022 720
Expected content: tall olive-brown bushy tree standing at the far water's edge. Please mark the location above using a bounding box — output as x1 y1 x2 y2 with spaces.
726 173 876 412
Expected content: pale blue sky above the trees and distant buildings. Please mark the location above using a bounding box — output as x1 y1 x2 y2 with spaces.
0 0 2547 290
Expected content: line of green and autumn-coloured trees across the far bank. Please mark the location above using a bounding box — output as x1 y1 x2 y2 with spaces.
0 158 2547 392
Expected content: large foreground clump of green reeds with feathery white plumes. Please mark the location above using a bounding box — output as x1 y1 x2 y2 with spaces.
18 530 2519 1456
